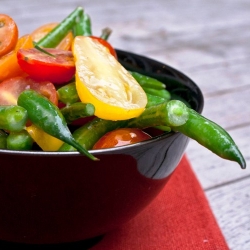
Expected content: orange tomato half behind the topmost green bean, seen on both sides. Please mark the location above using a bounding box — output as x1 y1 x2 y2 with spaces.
31 23 74 50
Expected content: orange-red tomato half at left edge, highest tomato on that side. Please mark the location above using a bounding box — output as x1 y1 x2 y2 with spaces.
0 14 18 57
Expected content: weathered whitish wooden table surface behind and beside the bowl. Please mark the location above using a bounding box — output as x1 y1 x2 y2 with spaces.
0 0 250 250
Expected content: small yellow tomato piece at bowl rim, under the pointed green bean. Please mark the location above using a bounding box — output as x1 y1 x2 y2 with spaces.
26 124 63 151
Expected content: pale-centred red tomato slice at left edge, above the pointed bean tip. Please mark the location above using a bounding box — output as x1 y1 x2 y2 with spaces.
0 76 58 105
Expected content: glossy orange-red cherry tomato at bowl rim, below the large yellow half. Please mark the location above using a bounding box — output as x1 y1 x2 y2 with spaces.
93 128 151 149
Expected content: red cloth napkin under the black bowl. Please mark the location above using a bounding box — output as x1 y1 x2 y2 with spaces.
91 156 229 250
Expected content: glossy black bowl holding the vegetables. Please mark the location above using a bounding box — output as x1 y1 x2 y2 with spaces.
0 50 203 244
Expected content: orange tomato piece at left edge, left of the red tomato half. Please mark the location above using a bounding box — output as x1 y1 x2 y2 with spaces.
0 35 33 82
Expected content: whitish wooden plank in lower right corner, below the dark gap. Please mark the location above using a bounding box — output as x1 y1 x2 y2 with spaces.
206 178 250 250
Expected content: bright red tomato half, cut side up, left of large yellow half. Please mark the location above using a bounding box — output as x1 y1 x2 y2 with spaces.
17 48 75 84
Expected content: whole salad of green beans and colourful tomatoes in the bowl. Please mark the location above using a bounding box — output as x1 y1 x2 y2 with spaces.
0 7 246 168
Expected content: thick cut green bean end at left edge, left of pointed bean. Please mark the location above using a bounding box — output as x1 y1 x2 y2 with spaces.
0 105 28 131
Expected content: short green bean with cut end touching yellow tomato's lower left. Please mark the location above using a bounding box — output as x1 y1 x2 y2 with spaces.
61 102 95 124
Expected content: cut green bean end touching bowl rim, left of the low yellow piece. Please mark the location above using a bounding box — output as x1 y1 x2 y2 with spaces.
7 130 34 150
